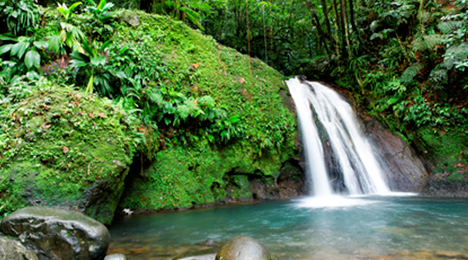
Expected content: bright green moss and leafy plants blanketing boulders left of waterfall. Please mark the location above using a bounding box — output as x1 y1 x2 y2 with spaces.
0 0 296 219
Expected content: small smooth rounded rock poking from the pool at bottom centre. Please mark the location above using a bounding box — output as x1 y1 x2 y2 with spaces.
216 236 274 260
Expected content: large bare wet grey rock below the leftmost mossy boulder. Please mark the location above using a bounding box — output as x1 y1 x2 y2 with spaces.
0 207 110 260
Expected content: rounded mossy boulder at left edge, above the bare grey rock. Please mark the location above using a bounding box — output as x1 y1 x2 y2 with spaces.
0 79 137 223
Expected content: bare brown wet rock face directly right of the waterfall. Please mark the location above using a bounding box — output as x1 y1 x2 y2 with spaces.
364 118 427 193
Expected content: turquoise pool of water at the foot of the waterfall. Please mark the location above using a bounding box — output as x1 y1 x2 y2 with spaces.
110 197 468 260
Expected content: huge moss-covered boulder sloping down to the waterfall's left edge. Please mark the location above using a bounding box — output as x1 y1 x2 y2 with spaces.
109 12 297 210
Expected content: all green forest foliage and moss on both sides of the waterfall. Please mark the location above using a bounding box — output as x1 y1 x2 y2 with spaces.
0 0 468 219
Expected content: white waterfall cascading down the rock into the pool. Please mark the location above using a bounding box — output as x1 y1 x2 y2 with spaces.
286 77 390 196
